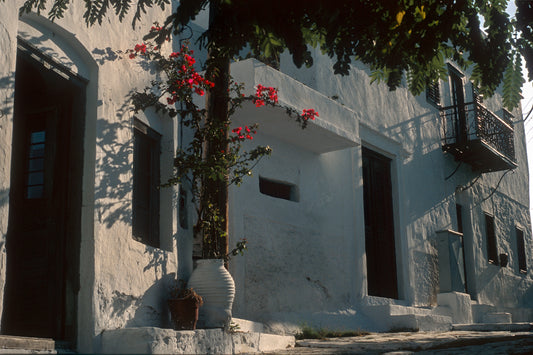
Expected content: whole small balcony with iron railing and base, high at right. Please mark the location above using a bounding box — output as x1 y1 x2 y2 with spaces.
440 100 517 173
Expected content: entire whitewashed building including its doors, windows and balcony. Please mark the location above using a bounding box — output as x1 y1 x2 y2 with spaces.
0 1 533 352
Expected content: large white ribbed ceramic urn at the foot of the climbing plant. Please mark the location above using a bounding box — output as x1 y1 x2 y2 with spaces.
188 259 235 328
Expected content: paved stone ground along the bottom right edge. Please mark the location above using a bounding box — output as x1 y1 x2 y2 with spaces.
270 331 533 355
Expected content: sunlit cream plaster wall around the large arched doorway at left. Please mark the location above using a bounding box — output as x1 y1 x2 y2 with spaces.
0 1 177 352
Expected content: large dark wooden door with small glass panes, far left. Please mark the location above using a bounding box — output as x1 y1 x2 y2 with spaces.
2 40 86 346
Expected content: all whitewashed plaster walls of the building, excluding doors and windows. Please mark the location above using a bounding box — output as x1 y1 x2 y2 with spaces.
0 1 533 352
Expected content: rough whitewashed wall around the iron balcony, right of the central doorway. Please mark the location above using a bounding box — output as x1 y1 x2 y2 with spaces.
298 49 532 305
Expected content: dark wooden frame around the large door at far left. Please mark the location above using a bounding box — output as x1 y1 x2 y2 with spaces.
2 37 88 348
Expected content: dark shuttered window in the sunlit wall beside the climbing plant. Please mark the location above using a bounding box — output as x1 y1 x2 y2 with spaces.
132 120 161 248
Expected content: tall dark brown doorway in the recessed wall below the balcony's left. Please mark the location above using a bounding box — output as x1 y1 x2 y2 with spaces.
362 147 398 299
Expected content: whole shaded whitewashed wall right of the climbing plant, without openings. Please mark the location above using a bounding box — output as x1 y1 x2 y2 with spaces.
223 48 533 330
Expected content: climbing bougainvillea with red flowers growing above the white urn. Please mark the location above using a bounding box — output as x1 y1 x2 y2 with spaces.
127 35 318 258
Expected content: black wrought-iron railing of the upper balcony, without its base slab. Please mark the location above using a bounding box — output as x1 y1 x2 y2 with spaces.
440 102 516 162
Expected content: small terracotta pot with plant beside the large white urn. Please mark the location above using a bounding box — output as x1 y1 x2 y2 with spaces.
167 280 203 330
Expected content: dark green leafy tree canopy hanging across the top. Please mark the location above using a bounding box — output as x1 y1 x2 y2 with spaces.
11 0 533 109
